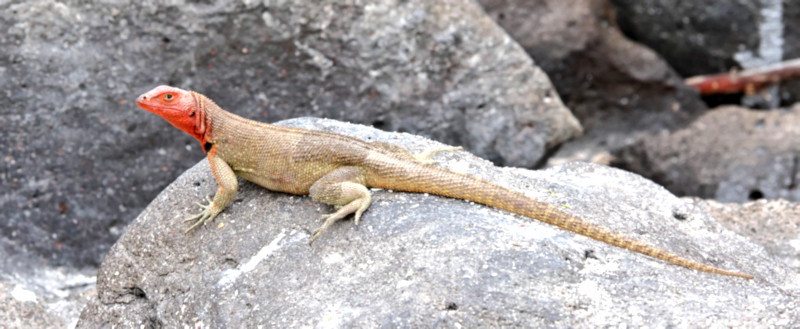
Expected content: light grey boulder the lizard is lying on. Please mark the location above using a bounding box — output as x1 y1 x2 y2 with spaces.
78 119 800 328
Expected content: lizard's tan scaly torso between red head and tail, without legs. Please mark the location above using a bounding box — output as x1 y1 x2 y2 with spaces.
208 110 408 194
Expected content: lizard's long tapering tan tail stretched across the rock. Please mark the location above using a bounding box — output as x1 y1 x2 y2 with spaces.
369 163 753 279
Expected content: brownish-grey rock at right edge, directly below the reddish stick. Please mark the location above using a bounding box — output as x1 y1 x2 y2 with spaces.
616 104 800 202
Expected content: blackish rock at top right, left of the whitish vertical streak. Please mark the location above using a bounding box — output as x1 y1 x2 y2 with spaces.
610 0 761 77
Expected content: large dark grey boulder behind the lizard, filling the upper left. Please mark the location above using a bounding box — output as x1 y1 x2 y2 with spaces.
0 0 580 266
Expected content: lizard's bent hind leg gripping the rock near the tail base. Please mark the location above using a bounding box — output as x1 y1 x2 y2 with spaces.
308 167 372 244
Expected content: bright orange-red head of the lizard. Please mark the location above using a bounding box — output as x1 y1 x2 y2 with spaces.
136 86 206 143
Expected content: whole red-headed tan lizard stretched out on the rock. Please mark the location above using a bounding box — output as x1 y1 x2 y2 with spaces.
136 86 753 279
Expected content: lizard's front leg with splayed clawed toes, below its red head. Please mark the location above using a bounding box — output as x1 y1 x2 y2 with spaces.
185 148 239 232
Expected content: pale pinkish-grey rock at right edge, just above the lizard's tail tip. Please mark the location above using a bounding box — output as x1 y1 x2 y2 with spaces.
692 198 800 272
